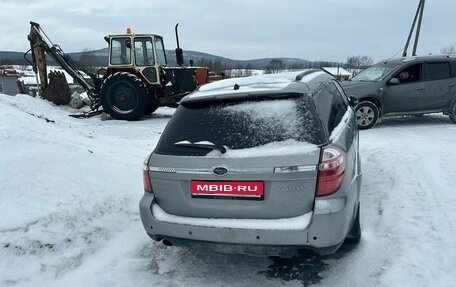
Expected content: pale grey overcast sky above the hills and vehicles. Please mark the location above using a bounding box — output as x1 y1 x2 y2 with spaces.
0 0 456 62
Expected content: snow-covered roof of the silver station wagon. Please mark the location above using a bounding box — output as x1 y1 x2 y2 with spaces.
181 70 333 103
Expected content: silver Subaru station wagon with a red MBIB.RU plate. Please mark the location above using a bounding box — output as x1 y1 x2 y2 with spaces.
140 70 361 257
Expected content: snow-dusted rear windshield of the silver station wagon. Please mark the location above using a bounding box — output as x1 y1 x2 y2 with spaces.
155 96 326 155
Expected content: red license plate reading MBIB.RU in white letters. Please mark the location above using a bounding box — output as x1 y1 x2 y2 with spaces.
190 180 264 199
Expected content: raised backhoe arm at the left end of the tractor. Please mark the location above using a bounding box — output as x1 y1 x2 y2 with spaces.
28 22 102 110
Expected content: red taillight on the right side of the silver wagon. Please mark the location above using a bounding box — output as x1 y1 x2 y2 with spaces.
316 146 345 196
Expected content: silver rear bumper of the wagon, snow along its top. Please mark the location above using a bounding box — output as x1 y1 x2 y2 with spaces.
139 192 355 256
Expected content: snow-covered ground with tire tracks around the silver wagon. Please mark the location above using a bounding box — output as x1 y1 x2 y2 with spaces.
0 95 456 286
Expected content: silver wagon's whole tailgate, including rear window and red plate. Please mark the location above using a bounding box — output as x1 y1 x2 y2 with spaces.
149 94 326 219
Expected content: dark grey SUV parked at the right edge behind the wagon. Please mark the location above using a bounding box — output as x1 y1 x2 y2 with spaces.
342 55 456 129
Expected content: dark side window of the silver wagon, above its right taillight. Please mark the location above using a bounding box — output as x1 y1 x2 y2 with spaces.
315 83 348 134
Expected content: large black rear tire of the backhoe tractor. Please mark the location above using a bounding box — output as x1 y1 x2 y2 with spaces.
100 72 148 121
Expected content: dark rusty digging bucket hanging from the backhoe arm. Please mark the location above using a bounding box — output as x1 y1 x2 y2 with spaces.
43 71 71 105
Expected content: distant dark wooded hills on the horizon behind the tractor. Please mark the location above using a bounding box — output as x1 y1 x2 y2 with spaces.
0 48 312 70
